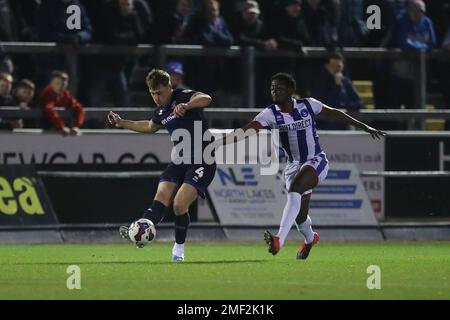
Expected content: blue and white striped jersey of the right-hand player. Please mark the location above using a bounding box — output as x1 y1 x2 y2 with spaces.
254 98 322 163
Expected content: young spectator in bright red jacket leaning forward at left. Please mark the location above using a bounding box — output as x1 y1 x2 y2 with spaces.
39 71 85 136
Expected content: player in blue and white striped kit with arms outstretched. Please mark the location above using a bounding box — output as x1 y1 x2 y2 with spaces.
220 73 386 259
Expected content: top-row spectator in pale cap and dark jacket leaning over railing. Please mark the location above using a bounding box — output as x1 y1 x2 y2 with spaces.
232 0 278 51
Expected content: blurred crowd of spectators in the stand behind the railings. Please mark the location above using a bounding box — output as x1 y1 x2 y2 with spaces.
0 0 450 135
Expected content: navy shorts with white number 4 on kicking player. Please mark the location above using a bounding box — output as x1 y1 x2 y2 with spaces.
159 163 216 199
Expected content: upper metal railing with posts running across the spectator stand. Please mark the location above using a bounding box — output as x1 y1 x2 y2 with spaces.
0 42 450 109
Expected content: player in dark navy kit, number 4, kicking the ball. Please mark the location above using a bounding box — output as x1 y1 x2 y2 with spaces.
108 69 216 261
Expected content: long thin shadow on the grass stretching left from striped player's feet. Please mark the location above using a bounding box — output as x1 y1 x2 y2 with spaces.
14 259 269 266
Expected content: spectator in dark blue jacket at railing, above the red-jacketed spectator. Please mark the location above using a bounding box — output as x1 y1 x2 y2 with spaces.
36 0 92 85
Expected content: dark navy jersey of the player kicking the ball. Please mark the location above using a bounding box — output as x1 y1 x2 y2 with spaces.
152 89 214 162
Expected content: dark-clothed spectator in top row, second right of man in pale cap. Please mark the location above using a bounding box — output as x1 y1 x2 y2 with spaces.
302 0 338 48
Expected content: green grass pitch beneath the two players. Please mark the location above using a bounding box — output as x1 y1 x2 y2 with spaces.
0 242 450 300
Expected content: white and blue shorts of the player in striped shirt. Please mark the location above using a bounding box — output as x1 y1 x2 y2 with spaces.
284 152 329 195
